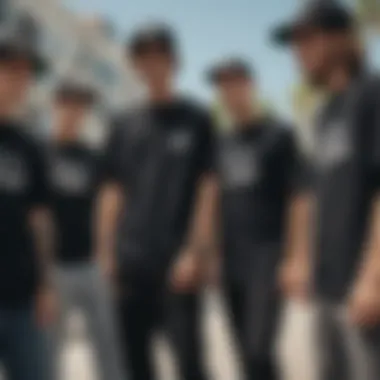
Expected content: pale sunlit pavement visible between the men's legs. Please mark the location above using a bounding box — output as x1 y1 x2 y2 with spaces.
62 293 315 380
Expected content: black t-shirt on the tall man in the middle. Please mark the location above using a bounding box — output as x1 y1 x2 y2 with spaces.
105 99 212 281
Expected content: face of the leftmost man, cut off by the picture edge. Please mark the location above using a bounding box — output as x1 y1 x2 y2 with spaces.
0 58 34 112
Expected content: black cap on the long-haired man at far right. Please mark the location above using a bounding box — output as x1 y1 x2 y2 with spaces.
272 0 355 45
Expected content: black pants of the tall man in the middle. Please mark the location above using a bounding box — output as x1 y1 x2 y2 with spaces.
120 288 206 380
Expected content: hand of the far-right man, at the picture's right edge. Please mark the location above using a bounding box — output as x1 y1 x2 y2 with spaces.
348 276 380 327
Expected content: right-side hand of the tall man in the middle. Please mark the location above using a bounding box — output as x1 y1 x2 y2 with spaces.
169 249 203 293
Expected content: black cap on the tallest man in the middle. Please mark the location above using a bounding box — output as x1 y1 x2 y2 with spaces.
127 23 177 56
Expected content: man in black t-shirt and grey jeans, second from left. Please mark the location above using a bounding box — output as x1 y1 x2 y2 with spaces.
49 78 124 380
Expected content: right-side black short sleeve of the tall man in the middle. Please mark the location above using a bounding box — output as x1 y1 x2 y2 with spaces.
198 110 215 174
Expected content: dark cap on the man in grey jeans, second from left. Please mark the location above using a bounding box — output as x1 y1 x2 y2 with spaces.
55 78 99 105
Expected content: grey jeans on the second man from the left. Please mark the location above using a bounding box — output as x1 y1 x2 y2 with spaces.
53 262 126 380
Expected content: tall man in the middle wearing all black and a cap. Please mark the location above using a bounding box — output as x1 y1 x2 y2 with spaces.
101 25 214 380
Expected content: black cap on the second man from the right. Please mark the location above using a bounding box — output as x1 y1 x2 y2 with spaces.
207 58 253 84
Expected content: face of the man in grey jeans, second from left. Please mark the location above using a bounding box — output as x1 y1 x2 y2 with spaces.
54 98 89 132
